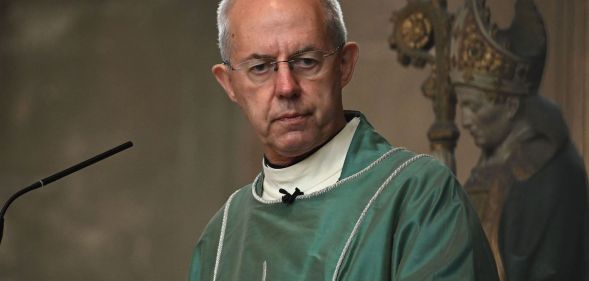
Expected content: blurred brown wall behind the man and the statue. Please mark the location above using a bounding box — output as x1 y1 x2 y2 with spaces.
0 0 589 281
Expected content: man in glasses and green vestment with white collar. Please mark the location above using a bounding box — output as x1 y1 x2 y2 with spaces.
190 0 496 281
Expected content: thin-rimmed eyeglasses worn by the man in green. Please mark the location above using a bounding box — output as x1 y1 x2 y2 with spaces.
223 44 344 84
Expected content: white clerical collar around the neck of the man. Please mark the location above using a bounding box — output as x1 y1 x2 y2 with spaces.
262 117 360 200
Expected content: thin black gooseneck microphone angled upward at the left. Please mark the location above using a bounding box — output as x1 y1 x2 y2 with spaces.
0 141 133 244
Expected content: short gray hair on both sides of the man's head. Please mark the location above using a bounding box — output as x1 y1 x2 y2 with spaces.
217 0 348 61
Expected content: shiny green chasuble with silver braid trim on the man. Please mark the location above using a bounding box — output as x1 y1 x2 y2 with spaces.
190 112 498 281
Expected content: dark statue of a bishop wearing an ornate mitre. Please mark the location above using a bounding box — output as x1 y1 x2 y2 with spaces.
450 0 589 281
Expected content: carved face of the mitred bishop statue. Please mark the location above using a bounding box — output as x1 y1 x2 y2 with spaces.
455 87 517 151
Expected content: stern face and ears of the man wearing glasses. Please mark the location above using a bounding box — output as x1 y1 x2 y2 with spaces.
213 0 358 165
